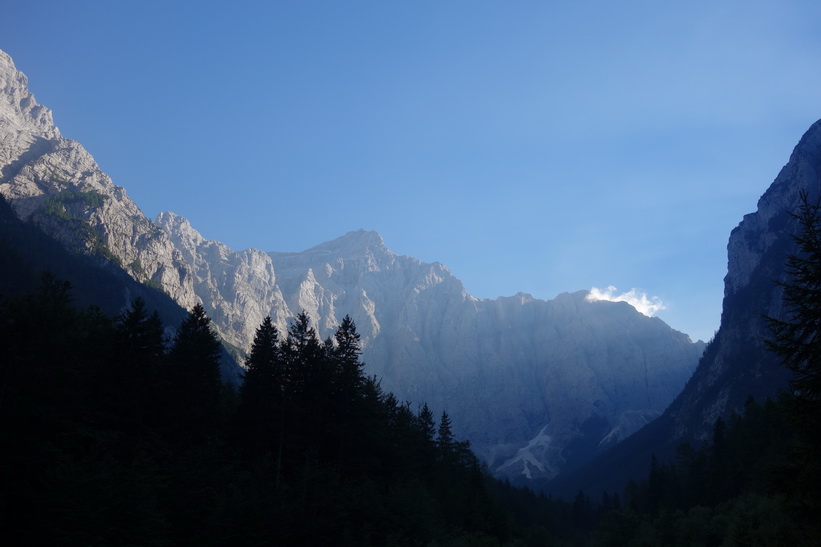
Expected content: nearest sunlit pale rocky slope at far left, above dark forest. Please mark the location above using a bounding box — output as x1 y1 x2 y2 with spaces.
0 51 197 308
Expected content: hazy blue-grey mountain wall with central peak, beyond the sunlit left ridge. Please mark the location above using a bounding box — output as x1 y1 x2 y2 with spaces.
156 171 703 479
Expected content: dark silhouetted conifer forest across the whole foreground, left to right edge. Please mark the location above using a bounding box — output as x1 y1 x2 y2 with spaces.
0 192 821 546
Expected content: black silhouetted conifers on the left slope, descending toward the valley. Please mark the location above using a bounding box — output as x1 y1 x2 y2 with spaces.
0 278 509 545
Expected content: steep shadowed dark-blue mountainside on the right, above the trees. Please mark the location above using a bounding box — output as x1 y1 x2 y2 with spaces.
547 120 821 497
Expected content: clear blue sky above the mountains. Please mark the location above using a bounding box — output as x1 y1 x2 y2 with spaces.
0 0 821 340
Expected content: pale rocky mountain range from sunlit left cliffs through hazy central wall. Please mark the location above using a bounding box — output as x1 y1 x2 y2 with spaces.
0 52 704 479
